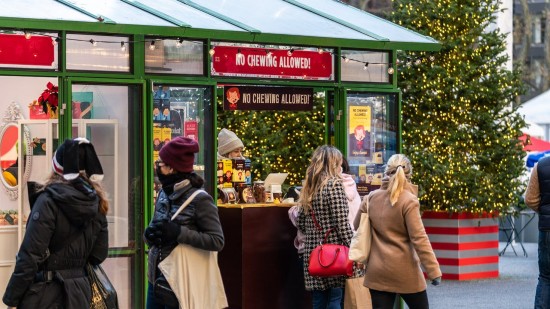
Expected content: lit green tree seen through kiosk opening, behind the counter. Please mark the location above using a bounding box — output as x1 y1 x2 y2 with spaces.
217 92 325 185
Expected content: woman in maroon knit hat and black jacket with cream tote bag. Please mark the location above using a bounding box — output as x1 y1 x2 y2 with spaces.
144 136 224 309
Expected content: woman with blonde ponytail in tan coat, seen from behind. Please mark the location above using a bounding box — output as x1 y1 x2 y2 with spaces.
354 154 441 309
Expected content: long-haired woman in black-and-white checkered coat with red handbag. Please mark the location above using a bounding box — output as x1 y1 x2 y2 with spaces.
298 145 359 309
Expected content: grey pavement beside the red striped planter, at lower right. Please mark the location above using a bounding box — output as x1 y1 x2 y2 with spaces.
426 242 538 309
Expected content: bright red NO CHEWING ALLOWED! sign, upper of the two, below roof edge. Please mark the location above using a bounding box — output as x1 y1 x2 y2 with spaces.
212 46 334 80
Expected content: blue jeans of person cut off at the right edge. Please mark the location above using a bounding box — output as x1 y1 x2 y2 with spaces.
535 231 550 309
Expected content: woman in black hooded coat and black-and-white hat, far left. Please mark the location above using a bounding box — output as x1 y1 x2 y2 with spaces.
2 138 109 309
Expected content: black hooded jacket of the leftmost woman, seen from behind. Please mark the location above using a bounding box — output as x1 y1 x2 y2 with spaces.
3 183 109 309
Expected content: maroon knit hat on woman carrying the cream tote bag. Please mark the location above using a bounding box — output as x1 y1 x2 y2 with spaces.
159 136 199 173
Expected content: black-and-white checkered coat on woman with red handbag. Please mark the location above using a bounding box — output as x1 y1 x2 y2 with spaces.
298 178 361 291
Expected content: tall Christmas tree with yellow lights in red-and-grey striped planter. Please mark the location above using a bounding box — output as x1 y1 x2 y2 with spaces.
391 0 525 213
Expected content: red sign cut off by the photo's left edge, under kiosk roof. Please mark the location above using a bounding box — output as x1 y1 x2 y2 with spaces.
0 34 55 68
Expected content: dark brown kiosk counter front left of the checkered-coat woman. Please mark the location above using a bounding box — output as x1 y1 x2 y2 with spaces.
218 203 311 309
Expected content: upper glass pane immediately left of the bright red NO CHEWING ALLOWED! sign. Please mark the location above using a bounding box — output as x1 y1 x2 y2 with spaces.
145 40 204 75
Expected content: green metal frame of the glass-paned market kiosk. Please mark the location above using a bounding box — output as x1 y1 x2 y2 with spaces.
0 7 441 308
